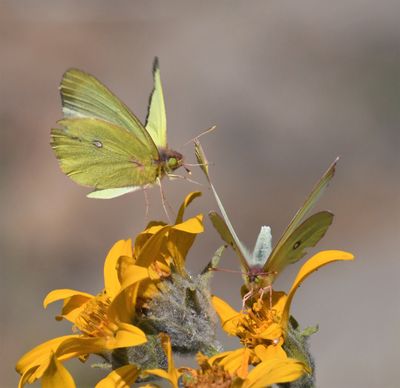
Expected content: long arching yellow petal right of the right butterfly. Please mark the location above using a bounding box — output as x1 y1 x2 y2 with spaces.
281 250 354 328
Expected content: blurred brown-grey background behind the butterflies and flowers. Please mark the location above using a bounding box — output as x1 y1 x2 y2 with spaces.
0 0 400 388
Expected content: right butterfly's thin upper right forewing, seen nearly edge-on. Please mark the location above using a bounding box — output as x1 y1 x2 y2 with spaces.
271 158 339 255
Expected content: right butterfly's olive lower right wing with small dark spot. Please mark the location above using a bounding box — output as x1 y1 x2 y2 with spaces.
264 211 333 282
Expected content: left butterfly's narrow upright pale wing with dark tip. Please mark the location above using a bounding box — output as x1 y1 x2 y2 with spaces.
146 58 167 148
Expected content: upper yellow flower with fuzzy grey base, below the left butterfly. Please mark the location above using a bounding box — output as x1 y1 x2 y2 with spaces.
124 192 220 358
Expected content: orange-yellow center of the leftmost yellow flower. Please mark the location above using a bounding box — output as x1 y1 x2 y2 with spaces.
75 292 117 337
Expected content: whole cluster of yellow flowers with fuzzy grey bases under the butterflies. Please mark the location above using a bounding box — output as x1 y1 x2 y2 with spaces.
16 192 353 388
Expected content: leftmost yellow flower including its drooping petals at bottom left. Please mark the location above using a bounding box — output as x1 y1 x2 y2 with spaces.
16 240 149 387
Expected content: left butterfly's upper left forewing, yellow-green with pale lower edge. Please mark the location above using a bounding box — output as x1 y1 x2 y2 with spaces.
60 69 153 148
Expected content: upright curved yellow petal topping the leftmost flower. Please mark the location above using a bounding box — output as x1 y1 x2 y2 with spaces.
104 239 132 299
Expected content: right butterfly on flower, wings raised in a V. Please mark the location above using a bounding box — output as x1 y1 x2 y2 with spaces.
195 142 338 302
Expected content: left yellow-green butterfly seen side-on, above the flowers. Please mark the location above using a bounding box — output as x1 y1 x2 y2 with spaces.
51 58 183 203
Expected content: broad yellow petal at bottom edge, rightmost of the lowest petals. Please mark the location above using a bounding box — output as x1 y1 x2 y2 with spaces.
243 358 305 388
